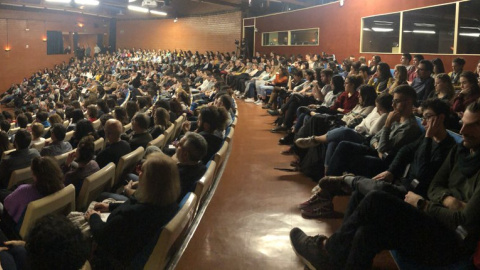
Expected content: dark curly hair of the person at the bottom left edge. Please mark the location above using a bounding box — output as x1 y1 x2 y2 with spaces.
25 214 90 270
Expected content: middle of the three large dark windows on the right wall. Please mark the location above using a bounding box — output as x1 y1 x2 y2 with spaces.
402 4 456 54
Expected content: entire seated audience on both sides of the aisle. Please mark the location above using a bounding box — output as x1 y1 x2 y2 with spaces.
0 46 480 268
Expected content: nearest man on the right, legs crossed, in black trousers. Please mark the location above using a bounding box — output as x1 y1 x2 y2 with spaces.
290 97 480 269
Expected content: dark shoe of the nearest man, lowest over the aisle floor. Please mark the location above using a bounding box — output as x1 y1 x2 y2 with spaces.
290 228 332 270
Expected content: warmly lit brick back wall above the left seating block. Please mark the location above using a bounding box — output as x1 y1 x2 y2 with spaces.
117 11 242 52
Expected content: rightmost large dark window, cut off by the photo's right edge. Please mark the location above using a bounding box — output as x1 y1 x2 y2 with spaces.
457 1 480 54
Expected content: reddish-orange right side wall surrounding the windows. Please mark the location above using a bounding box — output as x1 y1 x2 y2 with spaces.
255 0 480 70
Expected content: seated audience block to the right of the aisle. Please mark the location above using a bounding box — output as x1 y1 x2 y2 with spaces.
227 53 480 269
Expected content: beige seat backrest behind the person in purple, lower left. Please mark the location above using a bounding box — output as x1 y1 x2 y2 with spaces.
20 184 75 239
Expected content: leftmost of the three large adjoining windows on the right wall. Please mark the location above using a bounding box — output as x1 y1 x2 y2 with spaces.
362 13 400 53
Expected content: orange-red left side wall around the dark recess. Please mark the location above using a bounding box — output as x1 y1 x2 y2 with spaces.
0 9 108 93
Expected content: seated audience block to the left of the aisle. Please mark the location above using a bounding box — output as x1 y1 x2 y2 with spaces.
0 50 239 269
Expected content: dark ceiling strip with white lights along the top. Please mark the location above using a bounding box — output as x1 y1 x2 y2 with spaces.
0 0 336 20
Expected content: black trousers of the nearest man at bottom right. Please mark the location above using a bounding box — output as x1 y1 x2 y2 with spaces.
326 191 463 269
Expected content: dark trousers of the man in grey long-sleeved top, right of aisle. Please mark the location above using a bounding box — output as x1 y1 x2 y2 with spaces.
325 141 388 177
